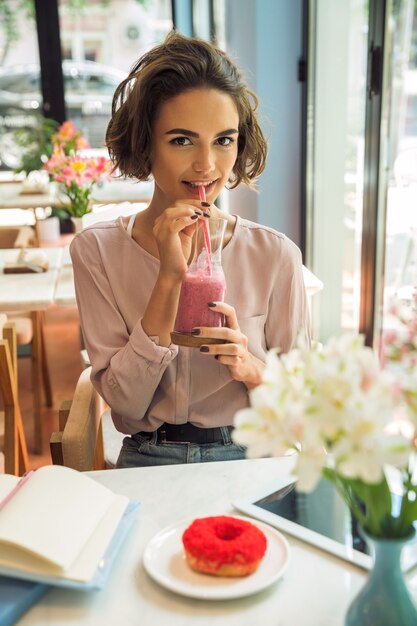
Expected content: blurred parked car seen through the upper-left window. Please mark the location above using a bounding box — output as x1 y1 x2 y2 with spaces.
0 61 126 170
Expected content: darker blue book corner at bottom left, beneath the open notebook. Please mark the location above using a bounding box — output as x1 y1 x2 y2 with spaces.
0 576 49 626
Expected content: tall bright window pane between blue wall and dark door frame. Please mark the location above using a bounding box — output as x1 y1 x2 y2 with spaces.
307 0 369 340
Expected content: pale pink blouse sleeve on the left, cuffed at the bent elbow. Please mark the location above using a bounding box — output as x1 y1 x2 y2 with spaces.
70 231 178 432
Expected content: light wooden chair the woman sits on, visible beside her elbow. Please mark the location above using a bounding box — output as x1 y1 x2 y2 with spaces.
50 367 124 472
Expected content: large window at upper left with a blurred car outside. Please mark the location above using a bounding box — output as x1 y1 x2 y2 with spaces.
0 0 172 169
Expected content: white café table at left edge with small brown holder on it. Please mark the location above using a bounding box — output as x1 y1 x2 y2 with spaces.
0 247 63 312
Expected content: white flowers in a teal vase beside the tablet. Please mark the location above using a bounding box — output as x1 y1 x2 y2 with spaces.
232 312 417 626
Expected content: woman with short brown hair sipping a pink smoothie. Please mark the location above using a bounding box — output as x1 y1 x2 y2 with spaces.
71 33 309 467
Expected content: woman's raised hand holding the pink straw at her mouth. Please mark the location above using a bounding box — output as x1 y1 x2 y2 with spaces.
152 200 206 279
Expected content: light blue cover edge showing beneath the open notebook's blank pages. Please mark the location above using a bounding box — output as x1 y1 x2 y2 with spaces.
0 500 139 588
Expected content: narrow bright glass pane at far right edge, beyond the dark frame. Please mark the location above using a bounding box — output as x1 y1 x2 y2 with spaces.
379 0 417 338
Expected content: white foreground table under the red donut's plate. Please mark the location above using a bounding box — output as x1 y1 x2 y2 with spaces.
19 458 417 626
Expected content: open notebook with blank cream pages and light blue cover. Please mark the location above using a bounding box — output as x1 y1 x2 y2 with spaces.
0 465 138 589
